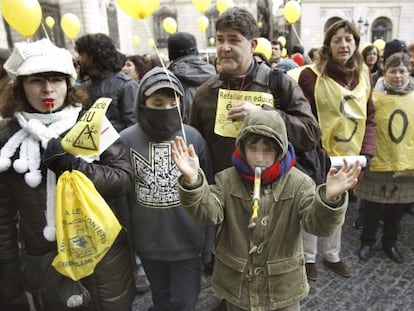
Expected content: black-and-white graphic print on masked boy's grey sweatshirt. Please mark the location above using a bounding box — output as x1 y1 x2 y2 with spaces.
131 142 180 208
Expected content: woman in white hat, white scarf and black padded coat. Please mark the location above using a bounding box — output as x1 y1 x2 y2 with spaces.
0 39 136 311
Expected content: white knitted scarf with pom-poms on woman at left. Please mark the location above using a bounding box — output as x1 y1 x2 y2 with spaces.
0 105 82 241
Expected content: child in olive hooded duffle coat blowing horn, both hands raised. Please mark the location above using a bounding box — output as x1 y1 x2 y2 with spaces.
172 110 361 311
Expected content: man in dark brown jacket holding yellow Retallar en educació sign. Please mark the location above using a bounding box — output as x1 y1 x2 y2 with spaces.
189 7 320 173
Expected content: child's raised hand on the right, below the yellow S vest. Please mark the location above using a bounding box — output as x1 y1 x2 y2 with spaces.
326 159 361 201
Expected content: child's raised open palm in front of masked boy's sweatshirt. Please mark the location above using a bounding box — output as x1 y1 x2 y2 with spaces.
171 136 200 185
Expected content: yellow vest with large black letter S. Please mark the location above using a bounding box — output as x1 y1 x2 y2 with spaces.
310 65 371 156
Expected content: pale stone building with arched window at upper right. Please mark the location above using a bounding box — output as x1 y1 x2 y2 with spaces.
300 0 414 49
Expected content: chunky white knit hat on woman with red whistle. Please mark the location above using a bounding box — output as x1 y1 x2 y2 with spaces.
3 39 77 85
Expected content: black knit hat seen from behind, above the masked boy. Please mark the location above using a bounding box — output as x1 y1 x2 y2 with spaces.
168 32 198 60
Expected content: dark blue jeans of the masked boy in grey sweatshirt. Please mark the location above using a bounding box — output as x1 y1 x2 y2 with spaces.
141 257 202 311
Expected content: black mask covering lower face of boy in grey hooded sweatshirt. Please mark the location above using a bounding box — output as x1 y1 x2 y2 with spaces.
139 107 181 141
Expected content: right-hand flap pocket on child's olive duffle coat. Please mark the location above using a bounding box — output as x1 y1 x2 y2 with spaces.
267 254 307 301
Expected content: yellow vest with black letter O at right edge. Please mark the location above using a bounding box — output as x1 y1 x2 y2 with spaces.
371 92 414 172
